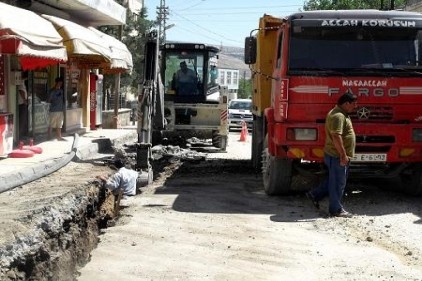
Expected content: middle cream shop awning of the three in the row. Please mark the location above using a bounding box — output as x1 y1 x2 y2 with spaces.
42 15 111 68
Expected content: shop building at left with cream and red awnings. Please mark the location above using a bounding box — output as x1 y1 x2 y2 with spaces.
0 0 139 151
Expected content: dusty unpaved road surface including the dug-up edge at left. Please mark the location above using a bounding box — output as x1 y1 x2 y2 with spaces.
0 133 422 281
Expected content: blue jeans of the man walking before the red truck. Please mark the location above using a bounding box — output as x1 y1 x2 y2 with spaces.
311 154 349 214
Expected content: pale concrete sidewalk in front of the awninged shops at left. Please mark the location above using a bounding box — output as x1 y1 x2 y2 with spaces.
0 127 137 193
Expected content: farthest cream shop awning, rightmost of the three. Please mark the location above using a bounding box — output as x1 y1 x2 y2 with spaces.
89 27 133 73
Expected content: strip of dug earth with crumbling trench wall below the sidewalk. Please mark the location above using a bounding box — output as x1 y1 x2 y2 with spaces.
0 159 120 280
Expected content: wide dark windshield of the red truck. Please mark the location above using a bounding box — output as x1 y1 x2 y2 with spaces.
288 26 422 74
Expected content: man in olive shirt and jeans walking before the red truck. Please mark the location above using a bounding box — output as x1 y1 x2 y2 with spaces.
306 92 357 217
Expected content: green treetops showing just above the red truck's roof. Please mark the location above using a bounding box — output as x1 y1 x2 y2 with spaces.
303 0 406 11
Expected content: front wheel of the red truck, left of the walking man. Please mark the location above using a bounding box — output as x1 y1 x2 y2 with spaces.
262 145 292 195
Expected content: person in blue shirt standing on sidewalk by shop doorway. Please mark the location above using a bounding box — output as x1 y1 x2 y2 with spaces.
48 77 66 141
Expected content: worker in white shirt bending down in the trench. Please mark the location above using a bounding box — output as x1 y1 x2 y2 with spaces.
97 159 139 199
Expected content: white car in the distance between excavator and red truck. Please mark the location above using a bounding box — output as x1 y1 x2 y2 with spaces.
229 99 253 130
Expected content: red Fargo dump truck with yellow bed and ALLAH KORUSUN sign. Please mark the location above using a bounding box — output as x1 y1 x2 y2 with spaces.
245 10 422 195
